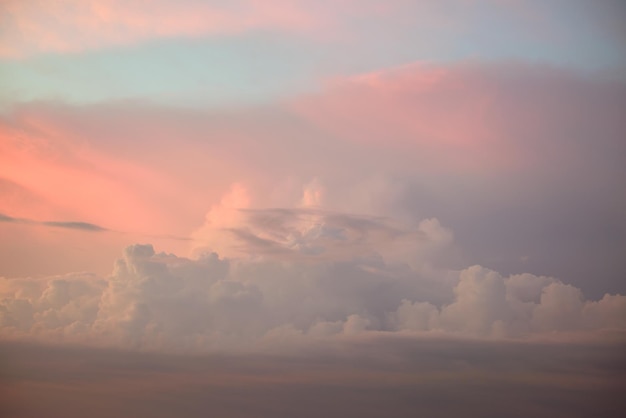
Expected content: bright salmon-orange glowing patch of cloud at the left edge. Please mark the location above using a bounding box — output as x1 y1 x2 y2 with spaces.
0 108 190 231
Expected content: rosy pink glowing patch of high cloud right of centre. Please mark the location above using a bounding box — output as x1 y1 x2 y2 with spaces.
294 64 514 173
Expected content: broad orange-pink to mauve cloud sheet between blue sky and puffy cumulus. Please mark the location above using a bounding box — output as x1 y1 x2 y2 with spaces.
0 63 626 299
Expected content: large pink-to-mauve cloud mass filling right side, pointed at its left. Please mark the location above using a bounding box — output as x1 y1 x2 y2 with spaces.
291 62 626 298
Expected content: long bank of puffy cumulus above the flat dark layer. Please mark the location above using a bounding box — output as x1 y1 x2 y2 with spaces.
0 208 626 352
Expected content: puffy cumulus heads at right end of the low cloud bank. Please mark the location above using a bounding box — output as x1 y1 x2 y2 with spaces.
392 266 626 336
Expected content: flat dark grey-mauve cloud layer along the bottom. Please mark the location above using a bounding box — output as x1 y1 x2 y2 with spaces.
0 336 626 418
